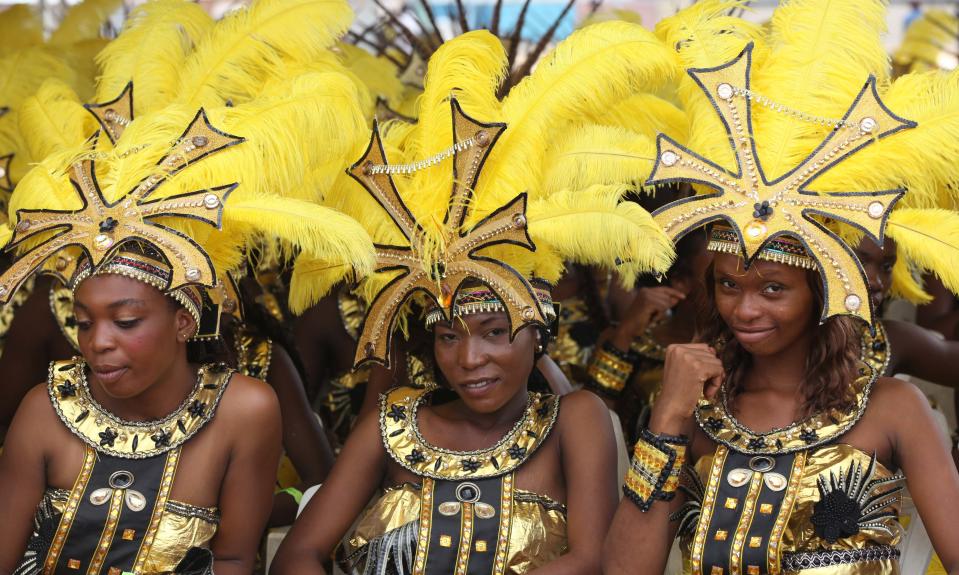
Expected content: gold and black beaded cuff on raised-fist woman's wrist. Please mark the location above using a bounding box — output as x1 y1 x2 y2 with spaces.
623 429 689 512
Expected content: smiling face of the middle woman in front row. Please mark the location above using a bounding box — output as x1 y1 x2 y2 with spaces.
433 312 537 413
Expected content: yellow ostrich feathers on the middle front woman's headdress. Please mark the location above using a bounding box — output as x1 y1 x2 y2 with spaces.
326 22 681 318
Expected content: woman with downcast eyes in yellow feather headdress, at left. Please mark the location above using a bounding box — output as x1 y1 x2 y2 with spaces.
0 0 373 574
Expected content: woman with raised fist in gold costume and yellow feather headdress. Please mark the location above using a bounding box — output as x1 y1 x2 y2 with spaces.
605 0 959 575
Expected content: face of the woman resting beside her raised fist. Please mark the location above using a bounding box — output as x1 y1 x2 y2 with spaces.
713 254 815 356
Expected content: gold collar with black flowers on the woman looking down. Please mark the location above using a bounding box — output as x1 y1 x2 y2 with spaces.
47 357 233 459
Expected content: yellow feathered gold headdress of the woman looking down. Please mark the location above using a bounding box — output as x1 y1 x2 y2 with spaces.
0 0 373 332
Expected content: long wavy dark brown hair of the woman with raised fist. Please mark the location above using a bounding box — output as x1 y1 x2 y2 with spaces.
697 263 860 415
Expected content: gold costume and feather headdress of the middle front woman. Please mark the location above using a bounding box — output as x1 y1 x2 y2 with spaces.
304 23 671 573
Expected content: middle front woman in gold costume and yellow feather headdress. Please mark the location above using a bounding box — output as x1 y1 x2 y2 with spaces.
274 19 671 574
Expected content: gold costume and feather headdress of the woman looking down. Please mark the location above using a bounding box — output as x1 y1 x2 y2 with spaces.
0 0 373 575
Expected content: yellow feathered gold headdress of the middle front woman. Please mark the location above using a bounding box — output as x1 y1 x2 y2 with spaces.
322 22 672 364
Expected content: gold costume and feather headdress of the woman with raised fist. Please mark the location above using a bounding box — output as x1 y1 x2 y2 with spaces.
556 0 959 575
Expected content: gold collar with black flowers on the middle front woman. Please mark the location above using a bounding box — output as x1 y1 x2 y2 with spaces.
380 387 559 481
